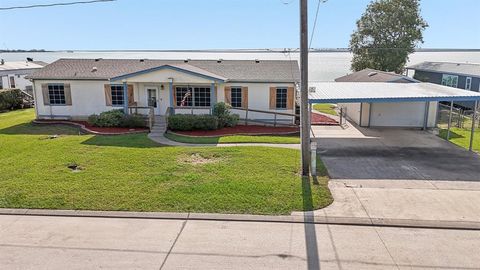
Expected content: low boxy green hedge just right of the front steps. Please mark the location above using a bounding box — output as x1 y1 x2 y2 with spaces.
168 114 218 130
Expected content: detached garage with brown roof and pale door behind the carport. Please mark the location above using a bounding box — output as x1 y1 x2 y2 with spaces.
335 69 438 127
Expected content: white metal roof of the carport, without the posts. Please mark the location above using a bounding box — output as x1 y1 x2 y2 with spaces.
308 82 480 103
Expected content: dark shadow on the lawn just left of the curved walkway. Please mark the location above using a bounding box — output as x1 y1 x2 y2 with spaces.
82 134 161 148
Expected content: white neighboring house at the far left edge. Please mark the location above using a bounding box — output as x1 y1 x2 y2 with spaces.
0 59 47 95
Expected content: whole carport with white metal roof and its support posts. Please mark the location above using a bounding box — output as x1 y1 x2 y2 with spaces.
309 82 480 151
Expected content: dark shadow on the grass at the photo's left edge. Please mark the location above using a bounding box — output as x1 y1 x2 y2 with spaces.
0 122 81 135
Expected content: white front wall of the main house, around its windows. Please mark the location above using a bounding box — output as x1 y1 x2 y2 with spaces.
34 76 295 123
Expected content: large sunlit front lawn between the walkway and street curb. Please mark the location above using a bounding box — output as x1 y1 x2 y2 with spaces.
0 109 332 214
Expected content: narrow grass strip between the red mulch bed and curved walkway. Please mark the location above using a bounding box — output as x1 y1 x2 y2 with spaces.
165 133 300 144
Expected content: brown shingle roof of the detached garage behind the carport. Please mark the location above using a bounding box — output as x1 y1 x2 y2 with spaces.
335 68 419 83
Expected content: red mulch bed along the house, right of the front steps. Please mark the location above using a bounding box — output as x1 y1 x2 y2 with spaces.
175 125 300 137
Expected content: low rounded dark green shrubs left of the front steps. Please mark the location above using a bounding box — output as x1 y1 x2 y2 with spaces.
88 110 146 128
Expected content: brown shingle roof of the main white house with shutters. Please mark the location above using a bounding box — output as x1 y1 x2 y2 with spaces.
29 59 300 82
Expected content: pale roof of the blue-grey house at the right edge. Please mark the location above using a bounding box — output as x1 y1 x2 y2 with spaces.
407 62 480 77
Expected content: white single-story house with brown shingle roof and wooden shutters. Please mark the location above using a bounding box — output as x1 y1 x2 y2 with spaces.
29 58 300 124
